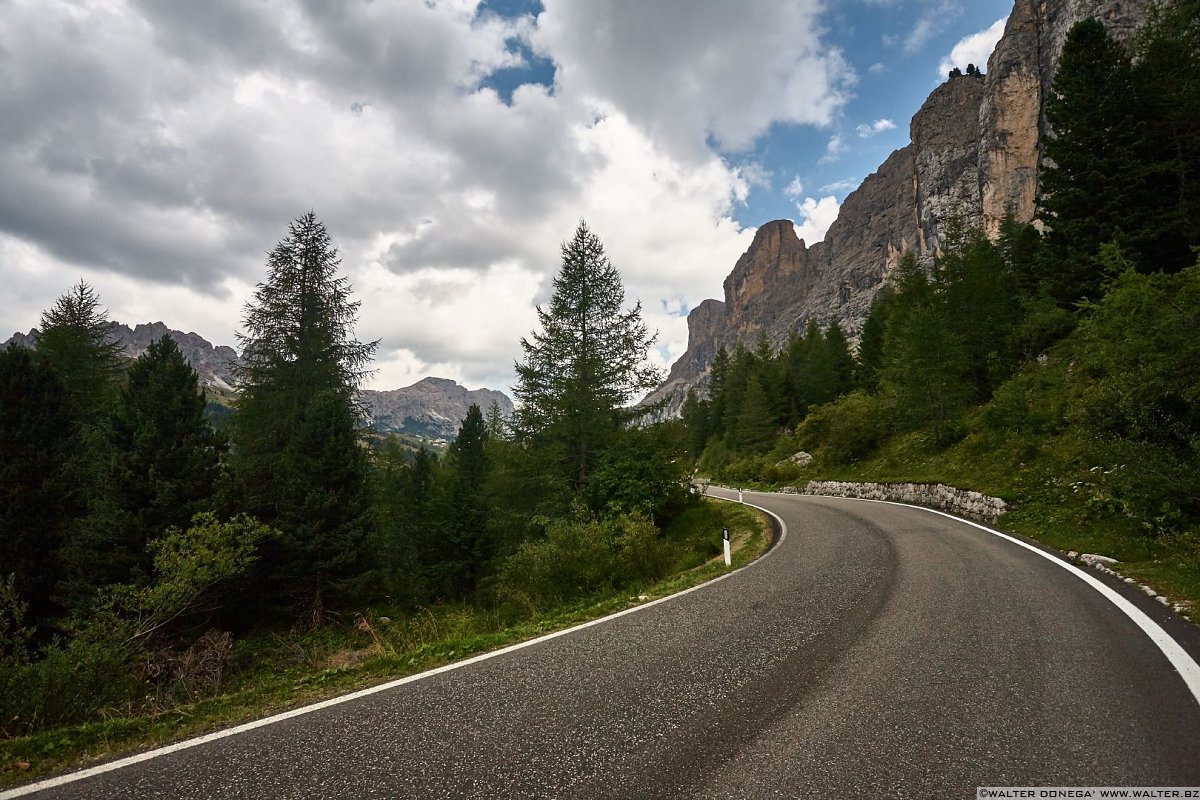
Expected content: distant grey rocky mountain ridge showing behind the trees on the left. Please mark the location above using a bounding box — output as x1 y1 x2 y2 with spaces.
4 321 514 441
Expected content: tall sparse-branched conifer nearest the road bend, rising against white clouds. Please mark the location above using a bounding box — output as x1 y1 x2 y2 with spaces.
514 222 660 494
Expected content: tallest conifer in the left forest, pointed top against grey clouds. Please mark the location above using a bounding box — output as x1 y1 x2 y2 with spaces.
230 211 377 619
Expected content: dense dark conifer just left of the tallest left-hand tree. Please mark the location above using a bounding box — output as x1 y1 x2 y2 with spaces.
73 336 224 588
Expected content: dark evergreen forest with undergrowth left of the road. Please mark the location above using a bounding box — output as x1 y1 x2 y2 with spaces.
0 212 748 766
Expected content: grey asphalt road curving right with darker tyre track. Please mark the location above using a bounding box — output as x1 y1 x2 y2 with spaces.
9 493 1200 800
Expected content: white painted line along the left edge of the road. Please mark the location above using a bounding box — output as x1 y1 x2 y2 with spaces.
0 495 787 800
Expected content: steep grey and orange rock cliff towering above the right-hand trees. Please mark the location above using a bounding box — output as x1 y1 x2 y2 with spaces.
646 0 1153 415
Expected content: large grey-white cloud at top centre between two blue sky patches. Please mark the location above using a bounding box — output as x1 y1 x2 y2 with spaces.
532 0 854 156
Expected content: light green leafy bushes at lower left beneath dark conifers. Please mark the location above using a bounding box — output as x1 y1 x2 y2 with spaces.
0 513 275 736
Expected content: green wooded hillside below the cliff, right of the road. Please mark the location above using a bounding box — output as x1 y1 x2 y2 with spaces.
684 9 1200 601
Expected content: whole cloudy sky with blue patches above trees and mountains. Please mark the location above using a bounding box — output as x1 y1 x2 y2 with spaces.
0 0 1012 389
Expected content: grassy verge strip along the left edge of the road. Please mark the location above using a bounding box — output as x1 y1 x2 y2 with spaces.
0 500 770 786
